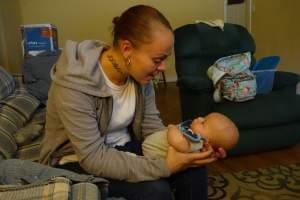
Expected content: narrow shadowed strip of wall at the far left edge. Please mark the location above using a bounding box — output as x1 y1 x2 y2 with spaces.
0 0 22 73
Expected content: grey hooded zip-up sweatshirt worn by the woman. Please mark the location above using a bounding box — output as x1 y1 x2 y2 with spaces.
40 40 170 182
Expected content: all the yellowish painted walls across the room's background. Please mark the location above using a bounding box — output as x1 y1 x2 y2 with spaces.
0 0 300 77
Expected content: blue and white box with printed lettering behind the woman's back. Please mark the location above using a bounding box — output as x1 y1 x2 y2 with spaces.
21 24 58 55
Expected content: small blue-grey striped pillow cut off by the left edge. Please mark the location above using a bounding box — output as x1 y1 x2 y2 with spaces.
0 66 15 100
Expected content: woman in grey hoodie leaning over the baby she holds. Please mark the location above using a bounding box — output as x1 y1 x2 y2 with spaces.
41 5 225 200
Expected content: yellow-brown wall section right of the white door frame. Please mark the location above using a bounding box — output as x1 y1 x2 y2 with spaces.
252 0 300 73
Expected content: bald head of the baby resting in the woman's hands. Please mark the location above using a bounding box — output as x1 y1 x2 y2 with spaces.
191 113 239 150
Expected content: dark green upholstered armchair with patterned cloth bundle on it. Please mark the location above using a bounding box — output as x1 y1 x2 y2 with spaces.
175 23 300 156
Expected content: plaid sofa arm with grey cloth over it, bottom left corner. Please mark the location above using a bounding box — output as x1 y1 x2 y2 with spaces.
0 159 108 200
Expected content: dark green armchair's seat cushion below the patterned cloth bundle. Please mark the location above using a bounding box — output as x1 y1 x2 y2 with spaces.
212 86 300 129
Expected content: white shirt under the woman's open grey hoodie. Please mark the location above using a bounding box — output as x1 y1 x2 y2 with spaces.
100 65 136 147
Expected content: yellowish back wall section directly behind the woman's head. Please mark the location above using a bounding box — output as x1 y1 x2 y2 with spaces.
19 0 224 81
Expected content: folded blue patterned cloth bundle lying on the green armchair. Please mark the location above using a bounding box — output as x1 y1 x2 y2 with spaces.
208 52 256 102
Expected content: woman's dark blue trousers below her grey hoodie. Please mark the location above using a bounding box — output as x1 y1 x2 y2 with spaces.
57 142 208 200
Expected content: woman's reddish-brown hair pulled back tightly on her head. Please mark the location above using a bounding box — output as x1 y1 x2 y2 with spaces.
112 5 172 47
